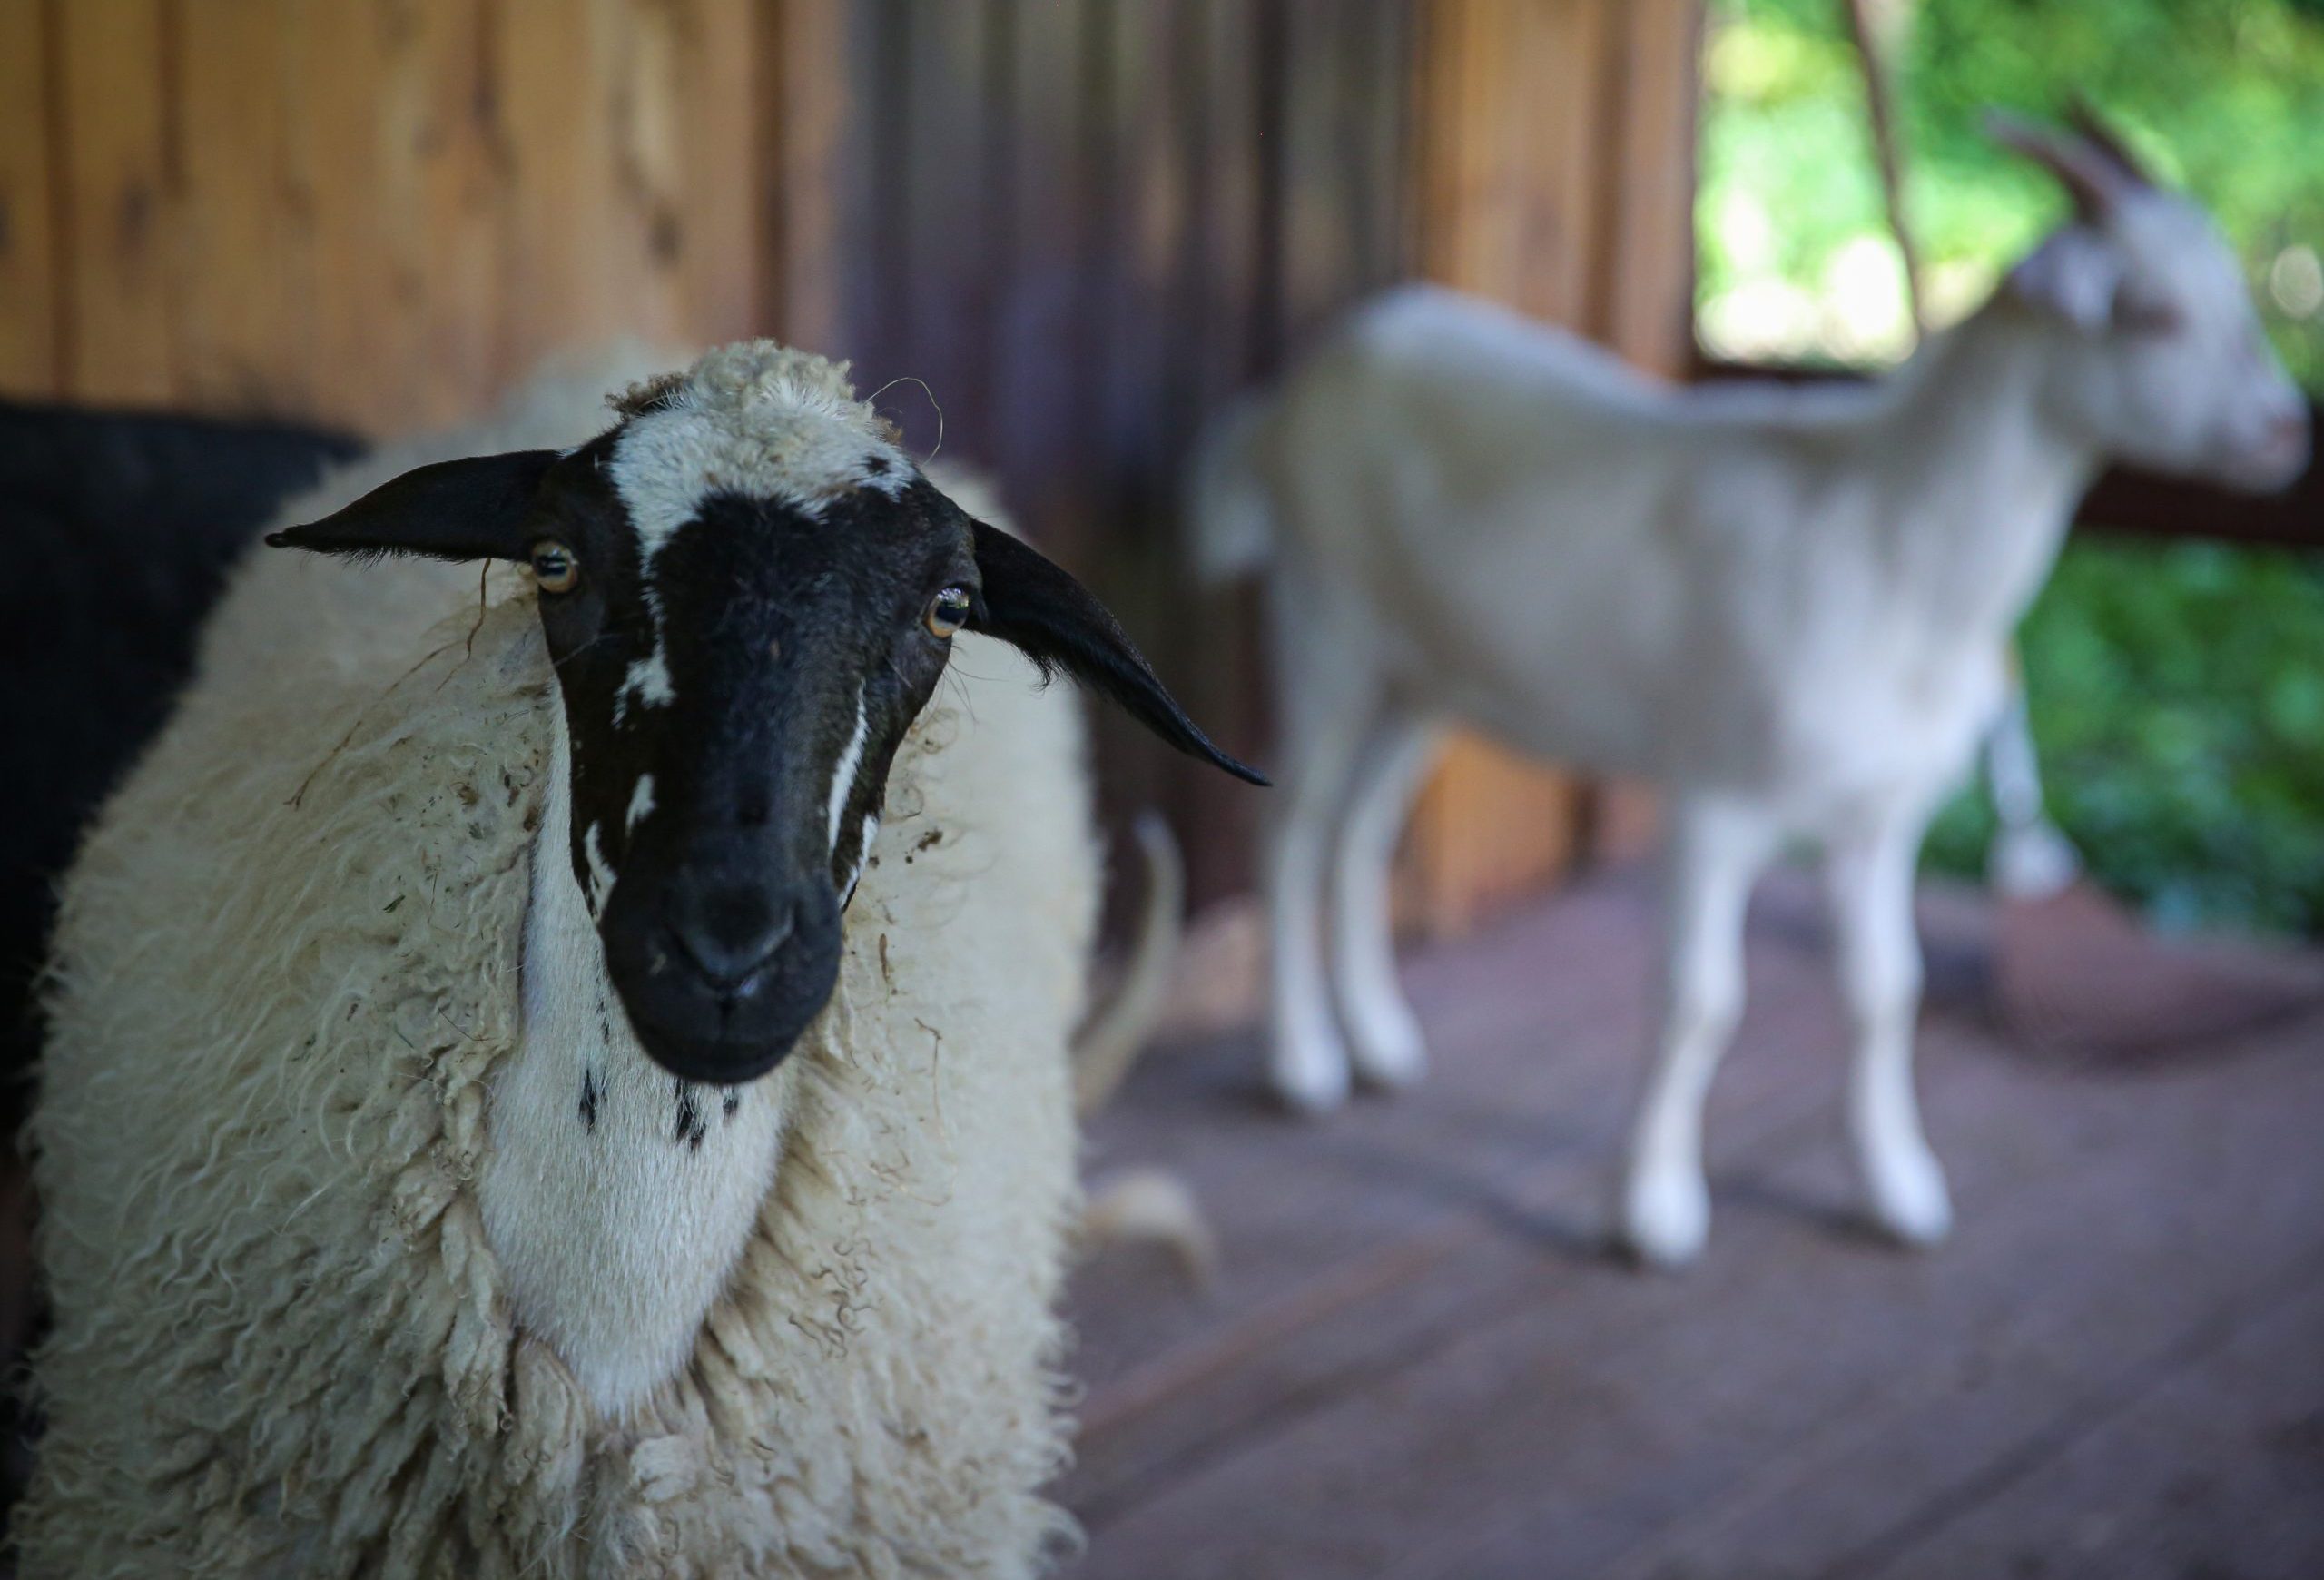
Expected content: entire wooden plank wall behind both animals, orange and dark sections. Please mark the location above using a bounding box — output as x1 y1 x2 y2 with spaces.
0 0 1699 927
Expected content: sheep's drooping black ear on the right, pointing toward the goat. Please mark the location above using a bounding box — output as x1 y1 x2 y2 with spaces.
970 520 1266 785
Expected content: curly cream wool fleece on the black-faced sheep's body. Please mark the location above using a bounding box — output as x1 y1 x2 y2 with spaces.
18 348 1097 1577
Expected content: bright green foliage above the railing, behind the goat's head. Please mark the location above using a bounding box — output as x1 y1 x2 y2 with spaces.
1697 0 2324 386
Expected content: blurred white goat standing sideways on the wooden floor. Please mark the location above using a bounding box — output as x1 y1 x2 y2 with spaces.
1195 123 2308 1261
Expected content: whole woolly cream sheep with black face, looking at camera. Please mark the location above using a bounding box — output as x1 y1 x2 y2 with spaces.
18 341 1255 1577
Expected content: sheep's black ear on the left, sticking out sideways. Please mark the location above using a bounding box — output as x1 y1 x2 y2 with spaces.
267 450 557 560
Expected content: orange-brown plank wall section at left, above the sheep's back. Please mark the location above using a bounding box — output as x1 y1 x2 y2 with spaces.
0 0 769 432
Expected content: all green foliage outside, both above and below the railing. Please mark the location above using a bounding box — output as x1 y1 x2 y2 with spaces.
1697 0 2324 936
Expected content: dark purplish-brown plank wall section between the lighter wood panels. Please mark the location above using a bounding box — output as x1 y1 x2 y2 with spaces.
842 0 1415 915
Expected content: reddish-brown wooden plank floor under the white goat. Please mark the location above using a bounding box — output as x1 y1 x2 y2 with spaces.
1062 876 2324 1580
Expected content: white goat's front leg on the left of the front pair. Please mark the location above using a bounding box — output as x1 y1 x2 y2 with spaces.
1615 799 1776 1267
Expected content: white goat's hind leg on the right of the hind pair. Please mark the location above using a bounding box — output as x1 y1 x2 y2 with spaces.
1332 714 1436 1085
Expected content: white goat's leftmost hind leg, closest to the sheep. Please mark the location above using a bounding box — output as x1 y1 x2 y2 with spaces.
1265 565 1378 1113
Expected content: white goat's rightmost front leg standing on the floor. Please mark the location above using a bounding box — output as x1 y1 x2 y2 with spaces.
1825 804 1952 1246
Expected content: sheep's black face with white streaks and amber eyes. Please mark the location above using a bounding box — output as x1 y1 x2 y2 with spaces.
541 450 980 1082
